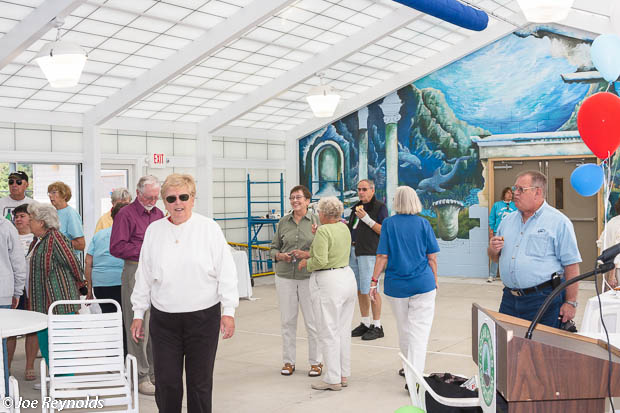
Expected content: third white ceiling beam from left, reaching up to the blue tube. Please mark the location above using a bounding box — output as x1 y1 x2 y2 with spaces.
200 7 424 133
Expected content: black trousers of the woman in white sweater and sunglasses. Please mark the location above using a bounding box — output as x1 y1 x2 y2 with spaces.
149 303 221 413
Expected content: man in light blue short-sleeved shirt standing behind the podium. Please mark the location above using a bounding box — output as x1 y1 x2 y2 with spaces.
488 171 581 327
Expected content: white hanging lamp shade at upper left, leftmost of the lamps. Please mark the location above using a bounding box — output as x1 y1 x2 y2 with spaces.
34 40 87 88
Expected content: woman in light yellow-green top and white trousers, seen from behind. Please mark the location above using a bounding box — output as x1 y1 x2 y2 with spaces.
299 197 357 390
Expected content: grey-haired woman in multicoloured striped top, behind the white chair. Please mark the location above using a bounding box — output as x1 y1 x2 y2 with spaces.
28 202 84 366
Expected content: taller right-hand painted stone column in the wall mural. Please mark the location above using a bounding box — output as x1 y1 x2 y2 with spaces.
379 92 403 214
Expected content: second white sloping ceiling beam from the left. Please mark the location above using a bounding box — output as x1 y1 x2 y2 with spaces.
85 0 294 125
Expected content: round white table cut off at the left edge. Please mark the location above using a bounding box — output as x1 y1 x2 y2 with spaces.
0 308 47 404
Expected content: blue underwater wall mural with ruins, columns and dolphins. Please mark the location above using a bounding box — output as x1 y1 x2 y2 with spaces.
299 26 606 276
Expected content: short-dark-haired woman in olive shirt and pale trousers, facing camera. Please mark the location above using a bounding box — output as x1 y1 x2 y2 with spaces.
271 185 323 377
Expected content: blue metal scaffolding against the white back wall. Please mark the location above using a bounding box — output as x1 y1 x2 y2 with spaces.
247 174 284 277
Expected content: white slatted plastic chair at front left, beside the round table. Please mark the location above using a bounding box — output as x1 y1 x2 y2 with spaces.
41 299 139 413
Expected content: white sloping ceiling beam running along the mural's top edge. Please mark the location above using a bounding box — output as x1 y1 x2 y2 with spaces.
286 16 516 139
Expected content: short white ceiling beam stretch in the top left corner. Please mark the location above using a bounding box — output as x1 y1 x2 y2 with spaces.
0 0 84 69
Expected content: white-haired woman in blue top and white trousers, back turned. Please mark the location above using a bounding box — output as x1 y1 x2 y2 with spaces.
370 186 439 373
